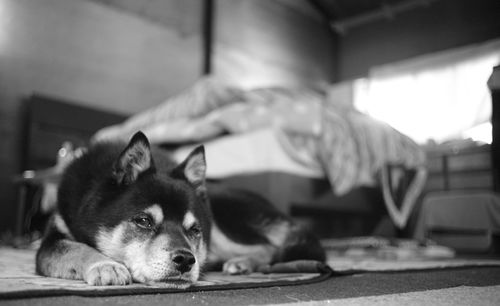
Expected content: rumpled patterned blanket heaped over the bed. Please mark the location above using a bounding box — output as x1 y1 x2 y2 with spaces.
93 77 425 195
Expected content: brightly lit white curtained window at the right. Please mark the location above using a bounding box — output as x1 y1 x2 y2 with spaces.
353 40 500 143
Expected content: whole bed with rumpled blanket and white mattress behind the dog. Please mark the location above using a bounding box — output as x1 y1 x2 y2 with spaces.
92 76 426 235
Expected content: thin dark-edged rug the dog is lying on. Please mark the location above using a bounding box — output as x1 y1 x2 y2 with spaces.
0 247 332 299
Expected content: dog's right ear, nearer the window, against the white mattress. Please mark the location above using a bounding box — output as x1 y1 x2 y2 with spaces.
172 146 207 188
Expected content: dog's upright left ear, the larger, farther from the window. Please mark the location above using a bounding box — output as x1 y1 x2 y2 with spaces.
113 132 153 185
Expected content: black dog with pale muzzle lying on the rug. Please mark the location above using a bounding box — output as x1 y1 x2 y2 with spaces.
36 132 325 288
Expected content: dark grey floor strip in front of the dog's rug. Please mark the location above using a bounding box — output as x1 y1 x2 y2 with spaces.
0 267 500 306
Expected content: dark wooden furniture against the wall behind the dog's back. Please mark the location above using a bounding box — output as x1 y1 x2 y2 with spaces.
14 94 125 236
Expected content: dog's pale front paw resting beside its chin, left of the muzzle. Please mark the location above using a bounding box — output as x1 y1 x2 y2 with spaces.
83 261 132 286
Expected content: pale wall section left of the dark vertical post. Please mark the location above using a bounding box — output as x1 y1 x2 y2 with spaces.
0 0 202 231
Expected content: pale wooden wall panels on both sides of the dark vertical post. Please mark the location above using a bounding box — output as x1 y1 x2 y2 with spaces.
0 0 335 231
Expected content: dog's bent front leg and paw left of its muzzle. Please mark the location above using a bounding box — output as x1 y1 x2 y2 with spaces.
36 225 132 286
